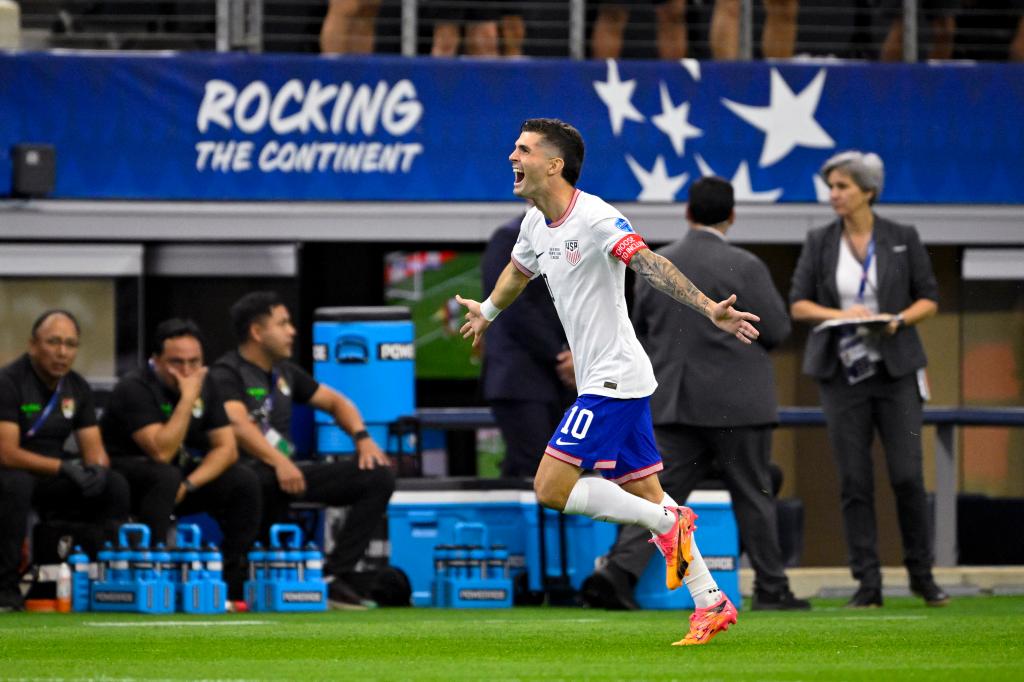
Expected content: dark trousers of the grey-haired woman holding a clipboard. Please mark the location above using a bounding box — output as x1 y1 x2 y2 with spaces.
818 368 934 587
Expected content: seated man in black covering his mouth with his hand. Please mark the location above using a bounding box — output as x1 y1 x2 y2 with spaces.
100 318 261 600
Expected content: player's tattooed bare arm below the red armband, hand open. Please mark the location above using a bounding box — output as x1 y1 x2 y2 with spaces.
630 249 761 343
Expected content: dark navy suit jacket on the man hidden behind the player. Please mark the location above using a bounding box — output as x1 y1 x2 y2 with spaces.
480 216 571 404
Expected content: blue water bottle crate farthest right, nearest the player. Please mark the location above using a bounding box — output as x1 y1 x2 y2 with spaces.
433 523 512 608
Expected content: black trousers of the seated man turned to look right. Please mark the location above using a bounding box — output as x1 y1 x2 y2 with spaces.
246 458 394 576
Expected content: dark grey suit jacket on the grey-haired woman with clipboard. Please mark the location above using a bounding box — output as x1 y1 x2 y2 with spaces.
790 215 939 379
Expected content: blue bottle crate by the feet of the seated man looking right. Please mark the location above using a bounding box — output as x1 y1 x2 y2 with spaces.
245 523 327 611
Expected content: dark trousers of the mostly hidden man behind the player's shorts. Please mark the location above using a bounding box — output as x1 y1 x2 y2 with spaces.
490 400 567 478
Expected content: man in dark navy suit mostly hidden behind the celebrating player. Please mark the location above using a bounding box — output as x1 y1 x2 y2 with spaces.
481 209 575 477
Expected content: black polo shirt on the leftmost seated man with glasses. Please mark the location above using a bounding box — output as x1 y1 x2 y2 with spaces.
0 353 96 459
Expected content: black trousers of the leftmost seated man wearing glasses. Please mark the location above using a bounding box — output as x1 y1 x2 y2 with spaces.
0 469 128 592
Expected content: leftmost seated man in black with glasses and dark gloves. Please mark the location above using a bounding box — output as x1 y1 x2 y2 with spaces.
0 310 128 611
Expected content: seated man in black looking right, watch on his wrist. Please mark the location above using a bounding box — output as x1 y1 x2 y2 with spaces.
211 292 394 608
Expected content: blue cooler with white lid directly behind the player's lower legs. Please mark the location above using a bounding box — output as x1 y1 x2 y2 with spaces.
634 491 741 609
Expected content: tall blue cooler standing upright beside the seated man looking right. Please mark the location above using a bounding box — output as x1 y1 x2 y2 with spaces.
313 306 416 455
